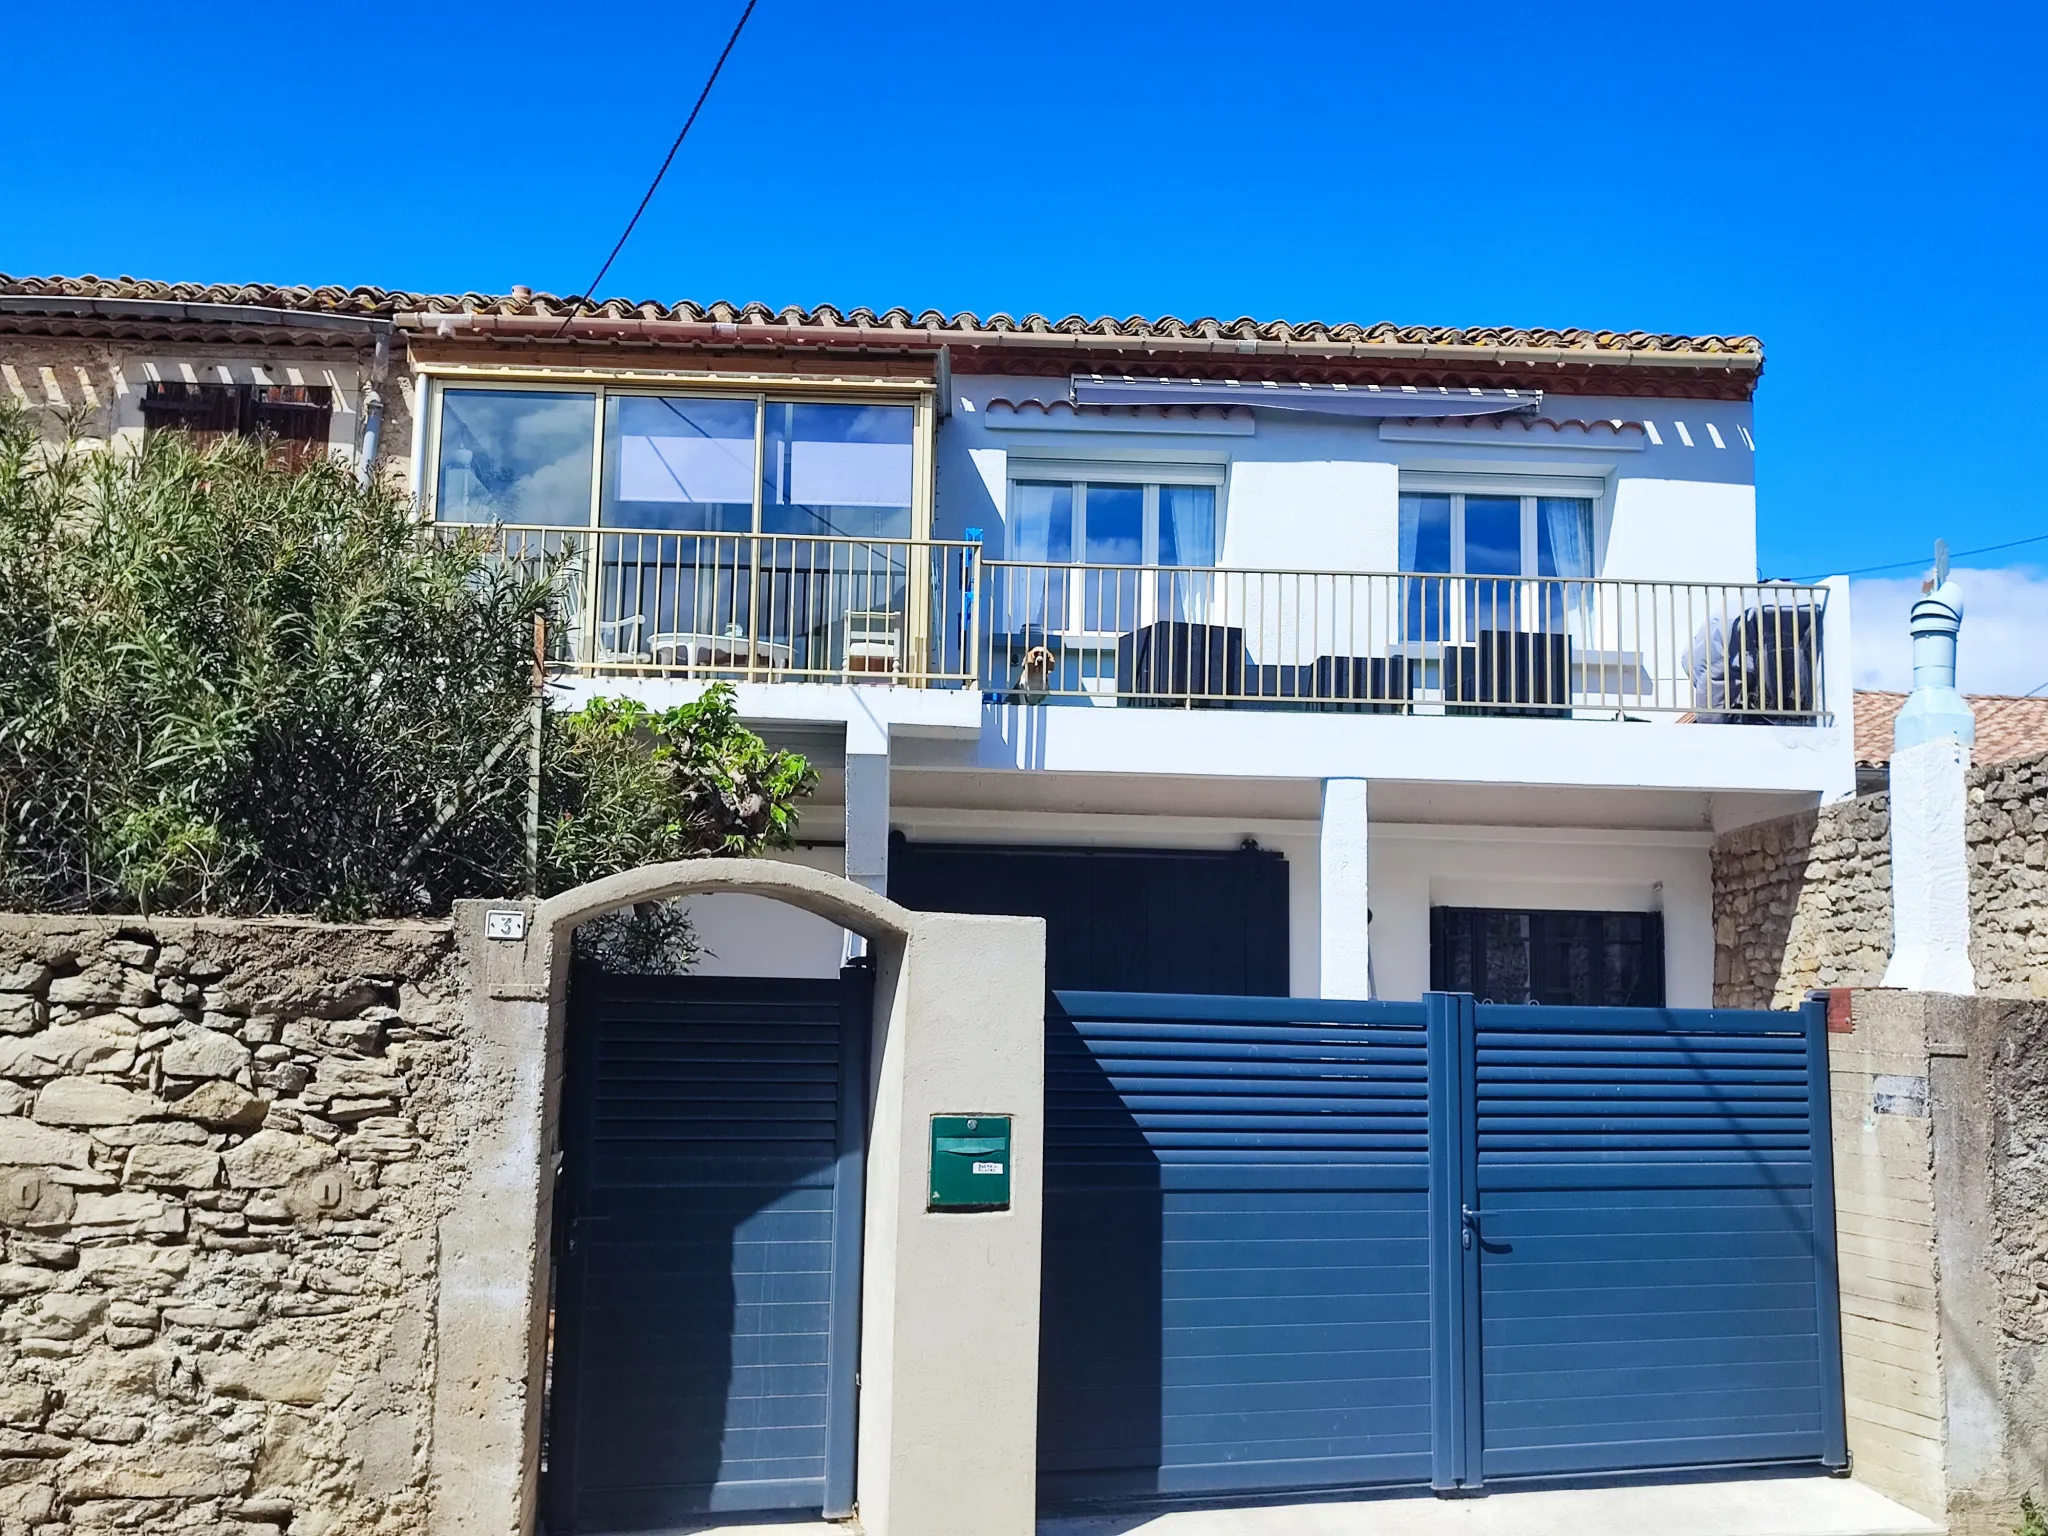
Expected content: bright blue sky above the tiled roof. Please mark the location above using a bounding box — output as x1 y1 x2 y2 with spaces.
0 0 2048 690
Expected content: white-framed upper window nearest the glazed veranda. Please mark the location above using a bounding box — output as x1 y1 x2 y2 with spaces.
1004 463 1221 635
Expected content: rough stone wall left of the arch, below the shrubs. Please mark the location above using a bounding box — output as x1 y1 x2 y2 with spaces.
0 918 475 1536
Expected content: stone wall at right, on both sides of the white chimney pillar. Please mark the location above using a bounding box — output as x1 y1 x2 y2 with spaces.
1712 758 2048 1008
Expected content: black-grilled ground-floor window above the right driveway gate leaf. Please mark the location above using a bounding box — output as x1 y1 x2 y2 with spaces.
1430 907 1665 1008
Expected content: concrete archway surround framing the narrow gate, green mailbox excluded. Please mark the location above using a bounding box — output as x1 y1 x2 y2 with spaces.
430 858 1044 1536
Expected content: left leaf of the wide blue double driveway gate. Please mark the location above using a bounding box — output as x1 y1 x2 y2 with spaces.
1038 993 1432 1503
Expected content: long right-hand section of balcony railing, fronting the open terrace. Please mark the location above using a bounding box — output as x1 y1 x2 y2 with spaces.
979 561 1827 723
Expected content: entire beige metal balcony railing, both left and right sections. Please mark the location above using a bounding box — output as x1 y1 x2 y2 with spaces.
483 524 1829 725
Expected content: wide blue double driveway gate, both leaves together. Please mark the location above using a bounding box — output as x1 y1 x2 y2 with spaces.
1038 991 1845 1503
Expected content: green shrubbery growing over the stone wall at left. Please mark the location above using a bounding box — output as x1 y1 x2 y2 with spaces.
0 408 813 918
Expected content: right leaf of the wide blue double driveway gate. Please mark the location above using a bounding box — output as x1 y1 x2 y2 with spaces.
1473 1008 1841 1477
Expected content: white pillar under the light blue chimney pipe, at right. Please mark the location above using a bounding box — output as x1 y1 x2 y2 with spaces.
1882 737 1976 995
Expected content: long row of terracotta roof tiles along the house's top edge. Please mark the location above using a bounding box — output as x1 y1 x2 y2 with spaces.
0 272 1763 356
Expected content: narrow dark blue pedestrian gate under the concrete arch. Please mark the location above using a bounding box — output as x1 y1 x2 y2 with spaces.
547 969 868 1536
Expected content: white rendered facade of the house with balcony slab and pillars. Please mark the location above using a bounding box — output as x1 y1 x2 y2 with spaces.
520 360 1853 1006
